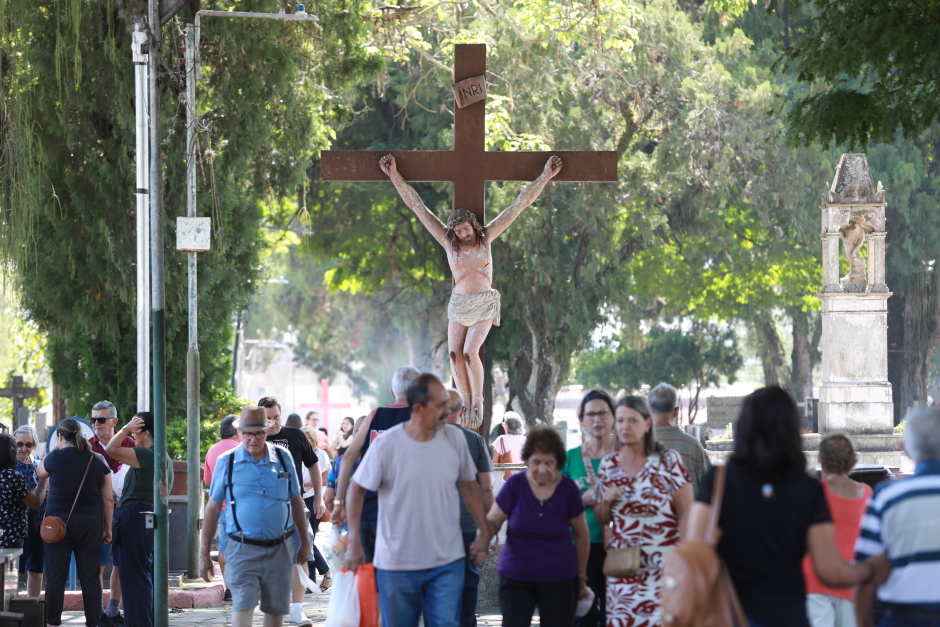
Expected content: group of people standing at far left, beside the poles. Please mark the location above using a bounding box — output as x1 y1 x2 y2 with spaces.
0 401 165 627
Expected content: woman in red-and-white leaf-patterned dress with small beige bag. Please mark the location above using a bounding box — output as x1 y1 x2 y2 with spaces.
594 396 693 627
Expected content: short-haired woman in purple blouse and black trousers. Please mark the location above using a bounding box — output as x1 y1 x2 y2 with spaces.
487 426 590 627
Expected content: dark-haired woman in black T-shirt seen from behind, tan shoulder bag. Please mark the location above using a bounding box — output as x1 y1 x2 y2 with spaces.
689 386 876 627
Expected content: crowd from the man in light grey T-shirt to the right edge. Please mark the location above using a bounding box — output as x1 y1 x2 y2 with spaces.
318 370 940 627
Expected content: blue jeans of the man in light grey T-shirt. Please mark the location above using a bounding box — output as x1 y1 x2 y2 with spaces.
375 558 464 627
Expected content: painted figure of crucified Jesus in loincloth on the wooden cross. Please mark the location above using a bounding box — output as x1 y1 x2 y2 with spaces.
379 155 562 428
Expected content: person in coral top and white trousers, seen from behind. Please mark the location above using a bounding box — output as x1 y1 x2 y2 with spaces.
803 433 872 627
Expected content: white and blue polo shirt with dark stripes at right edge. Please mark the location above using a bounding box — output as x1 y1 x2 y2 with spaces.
855 460 940 609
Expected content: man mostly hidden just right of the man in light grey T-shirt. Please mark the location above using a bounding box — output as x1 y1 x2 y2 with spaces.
445 388 493 627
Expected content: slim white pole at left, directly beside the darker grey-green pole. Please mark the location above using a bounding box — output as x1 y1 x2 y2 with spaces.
131 16 150 411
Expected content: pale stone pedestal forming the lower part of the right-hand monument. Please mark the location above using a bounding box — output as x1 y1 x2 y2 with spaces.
819 292 894 434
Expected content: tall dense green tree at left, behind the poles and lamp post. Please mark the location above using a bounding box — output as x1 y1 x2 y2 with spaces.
0 0 380 421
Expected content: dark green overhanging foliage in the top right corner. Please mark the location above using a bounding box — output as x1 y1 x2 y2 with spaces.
787 0 940 148
